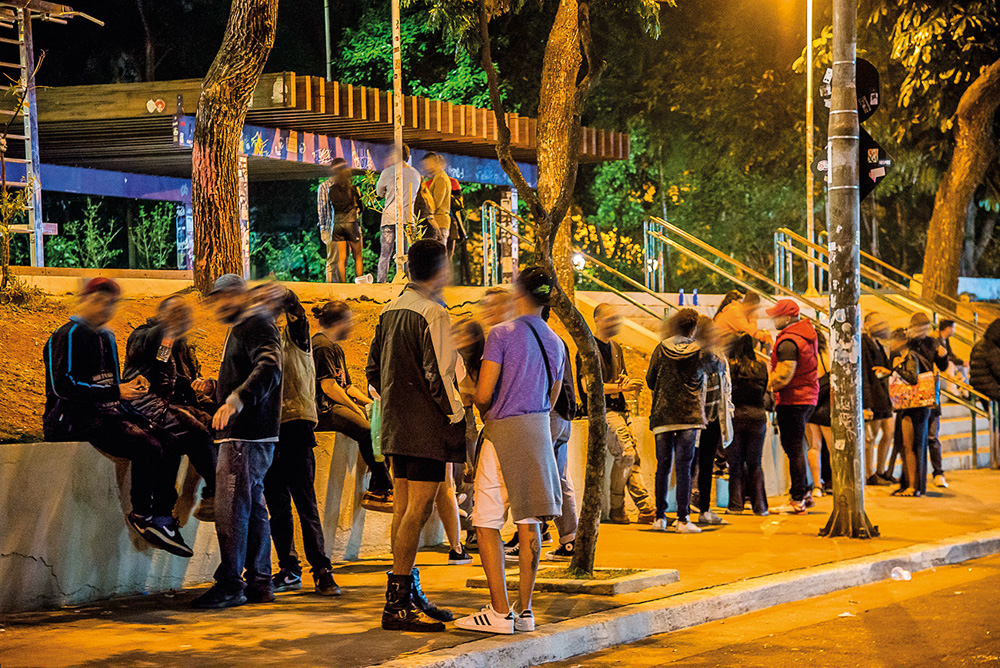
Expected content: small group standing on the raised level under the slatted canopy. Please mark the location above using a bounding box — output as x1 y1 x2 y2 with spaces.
316 144 467 283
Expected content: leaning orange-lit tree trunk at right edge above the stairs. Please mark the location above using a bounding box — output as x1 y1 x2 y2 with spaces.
923 60 1000 300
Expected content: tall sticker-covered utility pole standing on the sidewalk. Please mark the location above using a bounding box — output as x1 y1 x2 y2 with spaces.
821 0 878 538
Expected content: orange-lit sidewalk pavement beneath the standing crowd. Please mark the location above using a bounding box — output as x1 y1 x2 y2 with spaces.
0 470 1000 668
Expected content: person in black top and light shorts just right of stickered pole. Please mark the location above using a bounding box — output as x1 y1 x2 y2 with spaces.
861 311 896 485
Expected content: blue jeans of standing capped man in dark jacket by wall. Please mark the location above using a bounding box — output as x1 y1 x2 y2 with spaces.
215 441 274 592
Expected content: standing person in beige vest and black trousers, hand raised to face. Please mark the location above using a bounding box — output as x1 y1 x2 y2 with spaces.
264 288 340 596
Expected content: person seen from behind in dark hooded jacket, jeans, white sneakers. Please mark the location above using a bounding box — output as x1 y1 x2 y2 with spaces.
646 308 708 533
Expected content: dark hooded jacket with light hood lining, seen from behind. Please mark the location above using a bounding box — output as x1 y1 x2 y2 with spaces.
646 336 706 431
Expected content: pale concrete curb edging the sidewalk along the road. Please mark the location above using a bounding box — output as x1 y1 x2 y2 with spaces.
371 530 1000 668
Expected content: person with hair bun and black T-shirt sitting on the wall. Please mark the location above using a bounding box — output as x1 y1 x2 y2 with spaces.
312 301 392 513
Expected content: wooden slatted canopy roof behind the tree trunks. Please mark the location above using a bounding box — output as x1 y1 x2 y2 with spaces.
23 72 629 179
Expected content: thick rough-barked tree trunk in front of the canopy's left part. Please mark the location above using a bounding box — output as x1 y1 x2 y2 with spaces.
191 0 278 293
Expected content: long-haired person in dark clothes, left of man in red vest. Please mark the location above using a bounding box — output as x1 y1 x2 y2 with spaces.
726 334 769 515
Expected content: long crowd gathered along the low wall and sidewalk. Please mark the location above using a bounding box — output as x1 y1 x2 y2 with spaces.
44 249 1000 634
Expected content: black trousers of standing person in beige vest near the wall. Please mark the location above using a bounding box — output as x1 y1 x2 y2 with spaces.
264 420 330 575
